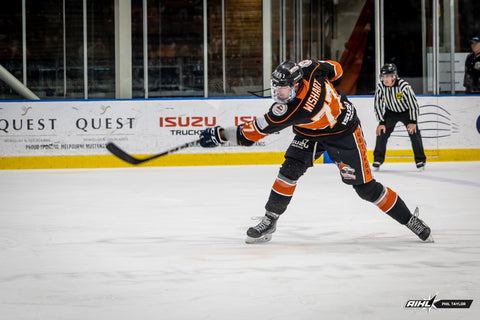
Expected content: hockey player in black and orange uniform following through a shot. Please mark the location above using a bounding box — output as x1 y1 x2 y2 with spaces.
200 60 431 243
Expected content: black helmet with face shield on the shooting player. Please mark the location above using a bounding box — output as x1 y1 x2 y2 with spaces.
271 61 303 103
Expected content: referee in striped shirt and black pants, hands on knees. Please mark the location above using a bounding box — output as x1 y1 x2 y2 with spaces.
373 63 427 170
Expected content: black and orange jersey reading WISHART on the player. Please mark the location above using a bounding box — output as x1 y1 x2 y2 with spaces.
238 60 359 145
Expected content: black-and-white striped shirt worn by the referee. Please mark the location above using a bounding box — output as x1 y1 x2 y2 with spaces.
375 78 419 124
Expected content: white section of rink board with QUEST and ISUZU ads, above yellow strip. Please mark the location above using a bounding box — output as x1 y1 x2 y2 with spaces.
0 96 480 157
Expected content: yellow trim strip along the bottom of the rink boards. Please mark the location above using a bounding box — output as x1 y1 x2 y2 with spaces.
0 149 480 170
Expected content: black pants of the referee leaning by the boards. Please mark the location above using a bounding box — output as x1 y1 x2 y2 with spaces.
373 110 427 163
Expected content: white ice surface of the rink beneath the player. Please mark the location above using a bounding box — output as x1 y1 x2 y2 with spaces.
0 162 480 320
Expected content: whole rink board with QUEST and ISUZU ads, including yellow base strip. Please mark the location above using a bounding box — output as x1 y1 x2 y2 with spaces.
0 96 480 169
